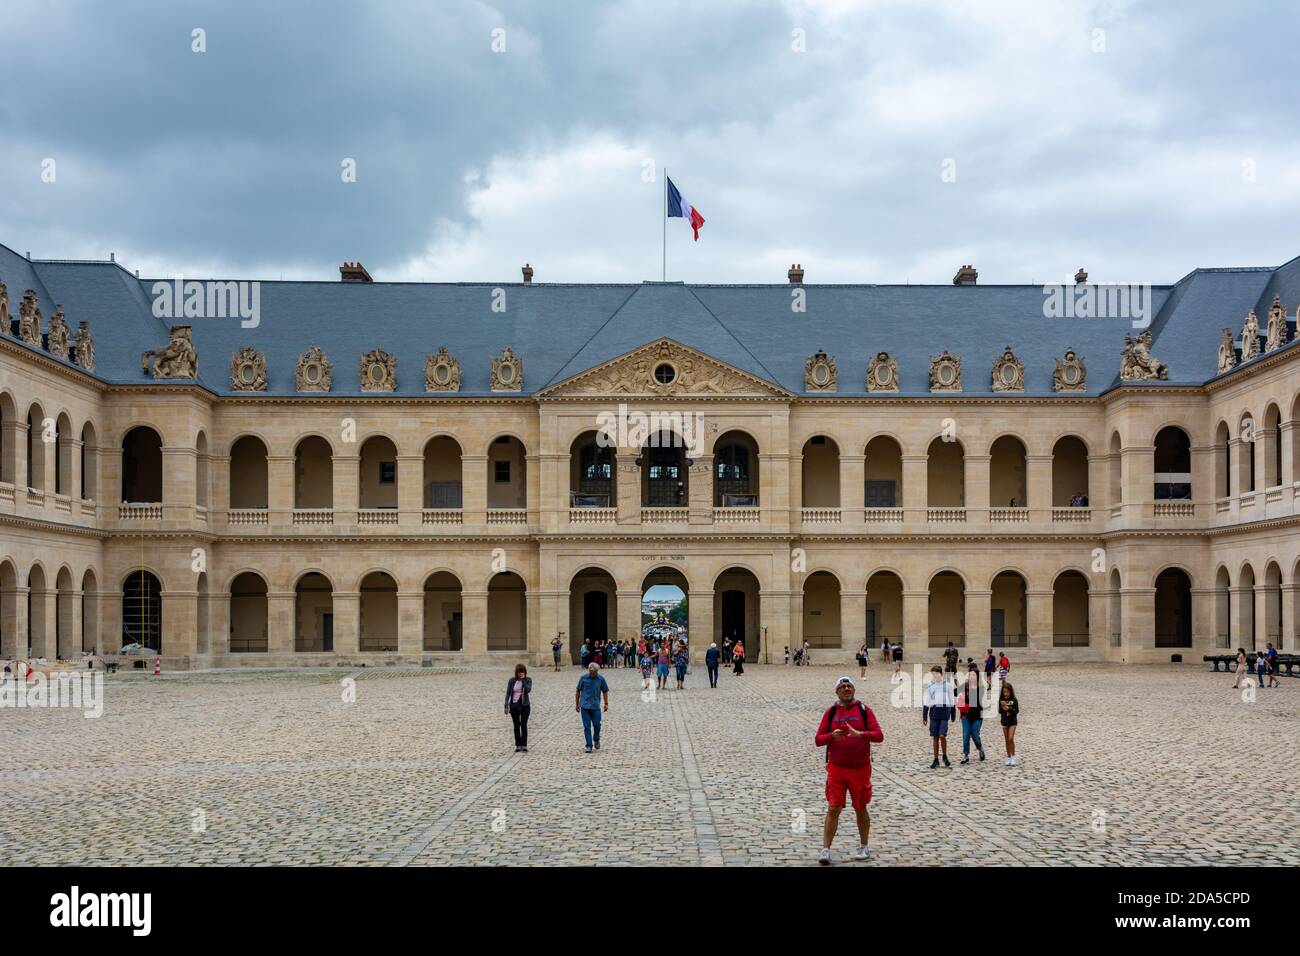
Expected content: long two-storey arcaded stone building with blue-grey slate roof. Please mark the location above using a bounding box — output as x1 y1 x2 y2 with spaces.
0 247 1300 667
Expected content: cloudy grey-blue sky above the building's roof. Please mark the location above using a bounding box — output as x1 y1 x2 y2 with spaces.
0 0 1300 282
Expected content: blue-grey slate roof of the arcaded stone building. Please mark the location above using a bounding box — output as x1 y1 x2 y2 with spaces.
0 246 1300 398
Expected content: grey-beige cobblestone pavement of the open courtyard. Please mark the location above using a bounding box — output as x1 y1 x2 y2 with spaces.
0 662 1300 866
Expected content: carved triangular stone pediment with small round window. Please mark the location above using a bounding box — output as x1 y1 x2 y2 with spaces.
541 338 792 398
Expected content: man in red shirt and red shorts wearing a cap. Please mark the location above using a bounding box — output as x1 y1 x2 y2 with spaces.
816 676 885 865
